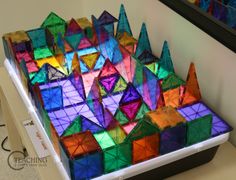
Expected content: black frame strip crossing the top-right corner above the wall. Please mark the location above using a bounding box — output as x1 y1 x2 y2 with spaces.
159 0 236 53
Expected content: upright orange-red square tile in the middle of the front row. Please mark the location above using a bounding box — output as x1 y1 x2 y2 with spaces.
132 134 159 164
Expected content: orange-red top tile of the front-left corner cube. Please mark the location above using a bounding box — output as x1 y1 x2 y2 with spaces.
61 131 100 158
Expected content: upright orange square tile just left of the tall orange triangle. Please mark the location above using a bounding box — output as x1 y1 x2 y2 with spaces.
163 87 180 107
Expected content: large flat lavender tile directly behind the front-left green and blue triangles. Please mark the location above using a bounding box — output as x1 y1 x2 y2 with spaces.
48 104 101 136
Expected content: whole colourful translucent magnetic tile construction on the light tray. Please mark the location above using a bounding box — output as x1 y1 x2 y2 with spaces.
3 5 231 179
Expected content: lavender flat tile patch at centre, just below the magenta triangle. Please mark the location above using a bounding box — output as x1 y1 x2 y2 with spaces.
102 93 123 115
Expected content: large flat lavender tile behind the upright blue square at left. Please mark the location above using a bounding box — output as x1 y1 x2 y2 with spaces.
40 80 84 107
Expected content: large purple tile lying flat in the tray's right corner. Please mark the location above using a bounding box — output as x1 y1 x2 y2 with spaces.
178 102 232 137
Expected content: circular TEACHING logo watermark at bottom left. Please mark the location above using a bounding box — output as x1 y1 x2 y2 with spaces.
7 151 47 171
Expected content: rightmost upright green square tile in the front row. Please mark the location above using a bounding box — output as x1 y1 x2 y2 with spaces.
187 115 212 145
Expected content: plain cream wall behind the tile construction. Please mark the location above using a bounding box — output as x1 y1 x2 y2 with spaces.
0 0 236 145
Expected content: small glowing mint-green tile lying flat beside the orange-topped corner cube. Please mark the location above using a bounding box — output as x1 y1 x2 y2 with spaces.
94 131 115 149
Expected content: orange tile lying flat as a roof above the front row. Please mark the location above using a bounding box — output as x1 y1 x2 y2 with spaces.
146 106 186 130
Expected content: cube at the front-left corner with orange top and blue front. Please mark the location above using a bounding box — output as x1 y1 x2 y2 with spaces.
61 131 103 179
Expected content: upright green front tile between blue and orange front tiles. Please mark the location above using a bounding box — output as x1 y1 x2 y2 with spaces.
103 143 132 173
